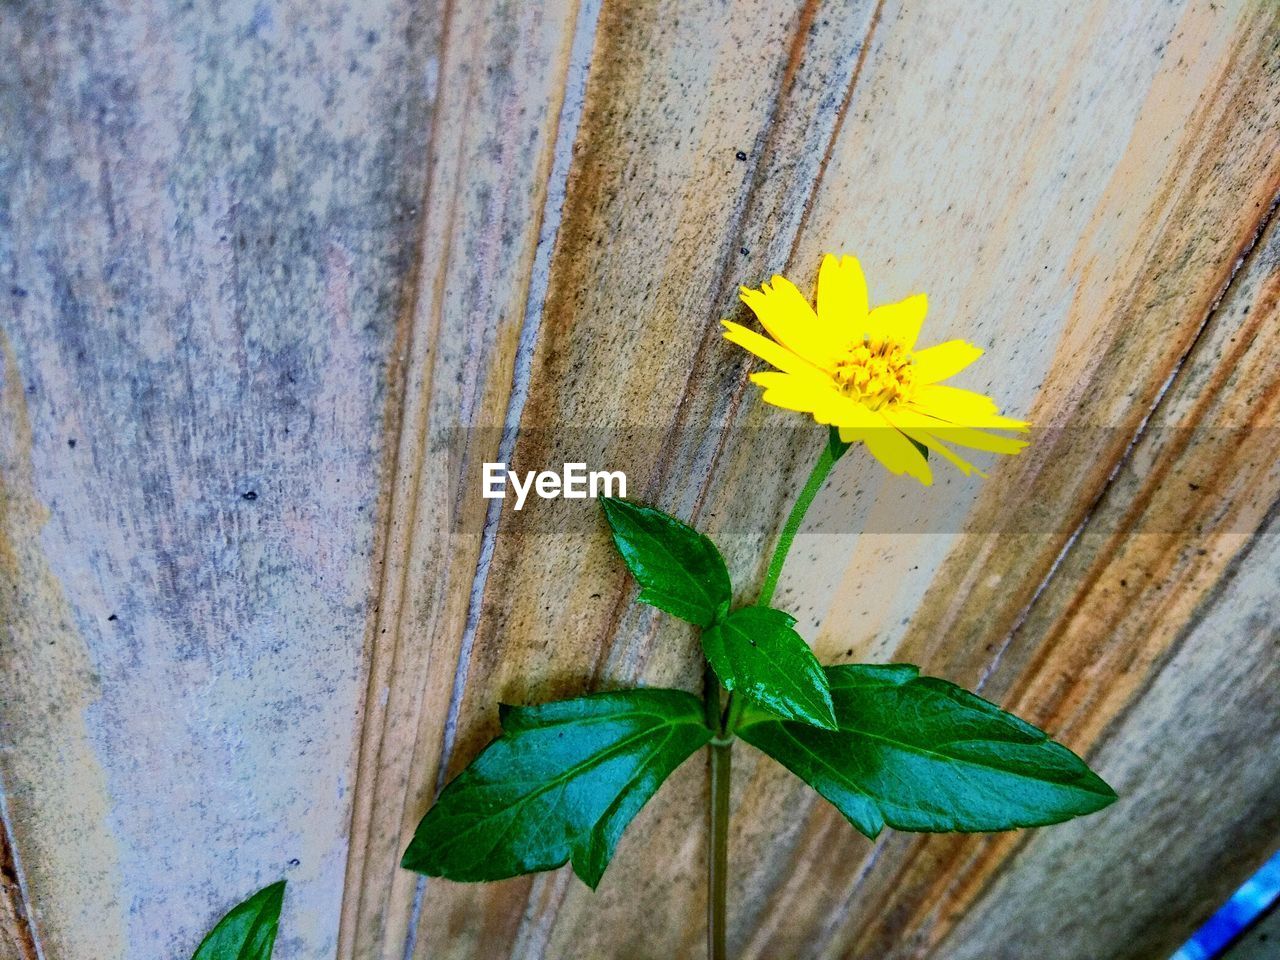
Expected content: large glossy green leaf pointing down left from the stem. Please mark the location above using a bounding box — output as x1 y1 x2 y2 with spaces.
401 690 712 890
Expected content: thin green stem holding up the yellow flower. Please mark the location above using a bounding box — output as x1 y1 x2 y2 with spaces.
703 434 845 960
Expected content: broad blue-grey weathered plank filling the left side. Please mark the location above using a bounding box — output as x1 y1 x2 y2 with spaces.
0 0 433 960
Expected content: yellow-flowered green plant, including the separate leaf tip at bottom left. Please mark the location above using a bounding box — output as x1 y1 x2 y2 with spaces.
185 256 1116 960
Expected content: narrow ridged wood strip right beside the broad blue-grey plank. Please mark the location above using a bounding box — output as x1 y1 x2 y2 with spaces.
339 0 594 960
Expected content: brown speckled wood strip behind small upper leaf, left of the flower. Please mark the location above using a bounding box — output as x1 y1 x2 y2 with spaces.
404 3 873 956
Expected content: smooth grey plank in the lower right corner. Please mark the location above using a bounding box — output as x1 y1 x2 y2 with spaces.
931 527 1280 960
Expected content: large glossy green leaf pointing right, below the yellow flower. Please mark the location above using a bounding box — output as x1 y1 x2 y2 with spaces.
737 664 1116 837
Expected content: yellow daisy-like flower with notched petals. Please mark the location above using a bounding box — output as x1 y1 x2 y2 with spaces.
723 253 1028 484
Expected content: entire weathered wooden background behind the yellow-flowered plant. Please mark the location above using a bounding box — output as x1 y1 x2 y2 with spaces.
0 0 1280 960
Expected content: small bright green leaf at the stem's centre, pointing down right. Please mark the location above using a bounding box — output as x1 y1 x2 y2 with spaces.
703 607 836 730
